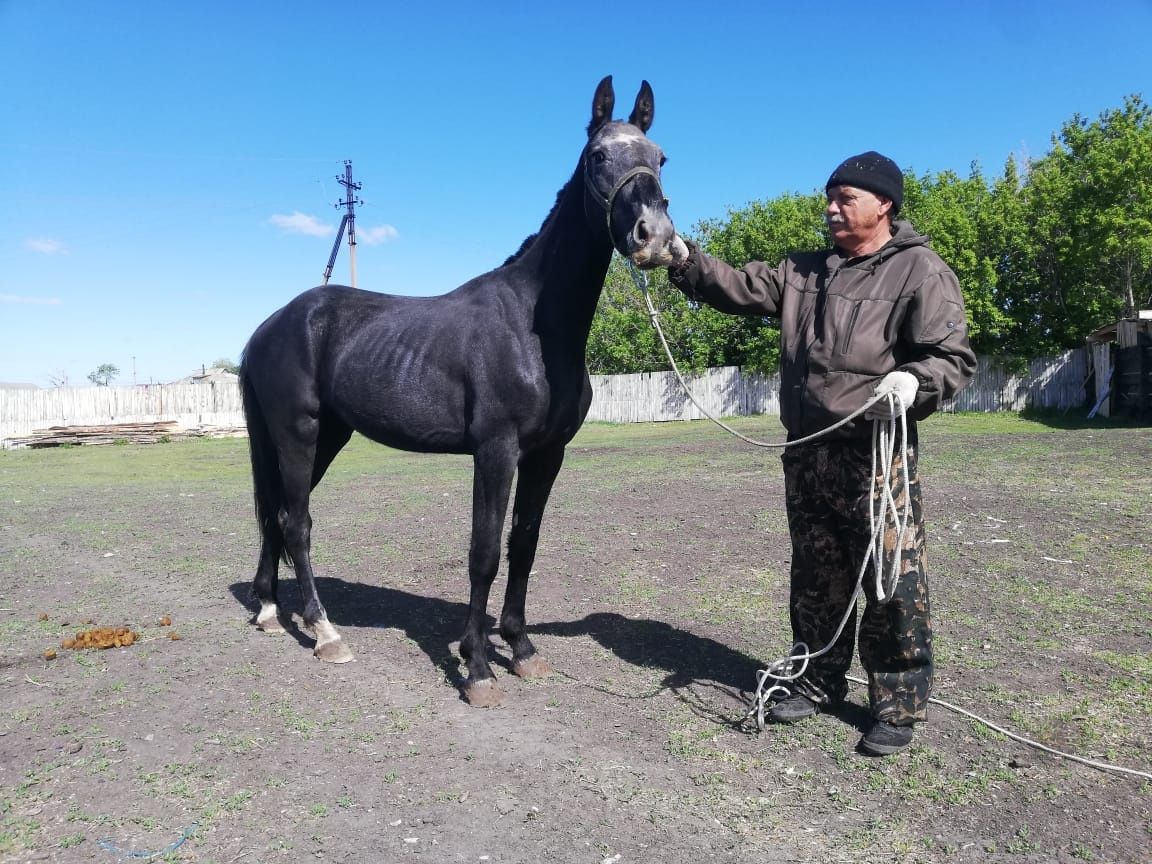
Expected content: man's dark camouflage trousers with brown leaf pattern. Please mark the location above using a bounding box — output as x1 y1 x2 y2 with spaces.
782 440 932 726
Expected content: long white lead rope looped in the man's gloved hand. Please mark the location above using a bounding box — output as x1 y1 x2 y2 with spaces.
624 258 1152 780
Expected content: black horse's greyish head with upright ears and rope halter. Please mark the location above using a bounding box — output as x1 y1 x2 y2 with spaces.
581 75 688 268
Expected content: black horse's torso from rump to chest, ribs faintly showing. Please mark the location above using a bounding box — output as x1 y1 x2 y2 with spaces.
244 280 588 453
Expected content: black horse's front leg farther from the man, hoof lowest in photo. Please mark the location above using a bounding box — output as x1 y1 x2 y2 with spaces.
460 440 520 707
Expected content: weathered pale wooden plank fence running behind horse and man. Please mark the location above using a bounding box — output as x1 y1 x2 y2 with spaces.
0 349 1090 442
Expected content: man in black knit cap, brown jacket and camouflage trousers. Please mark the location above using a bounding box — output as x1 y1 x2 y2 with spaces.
669 151 976 756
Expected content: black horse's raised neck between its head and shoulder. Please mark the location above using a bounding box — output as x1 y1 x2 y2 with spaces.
520 172 612 347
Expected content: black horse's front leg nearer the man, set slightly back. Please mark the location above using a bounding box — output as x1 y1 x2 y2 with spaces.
500 447 564 677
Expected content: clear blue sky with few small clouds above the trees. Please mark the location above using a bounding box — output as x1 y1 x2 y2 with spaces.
0 0 1152 386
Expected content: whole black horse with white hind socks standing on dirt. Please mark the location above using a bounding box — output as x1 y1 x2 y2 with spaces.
241 76 687 705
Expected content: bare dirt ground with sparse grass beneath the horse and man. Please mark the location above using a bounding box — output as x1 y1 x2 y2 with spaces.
0 417 1152 864
